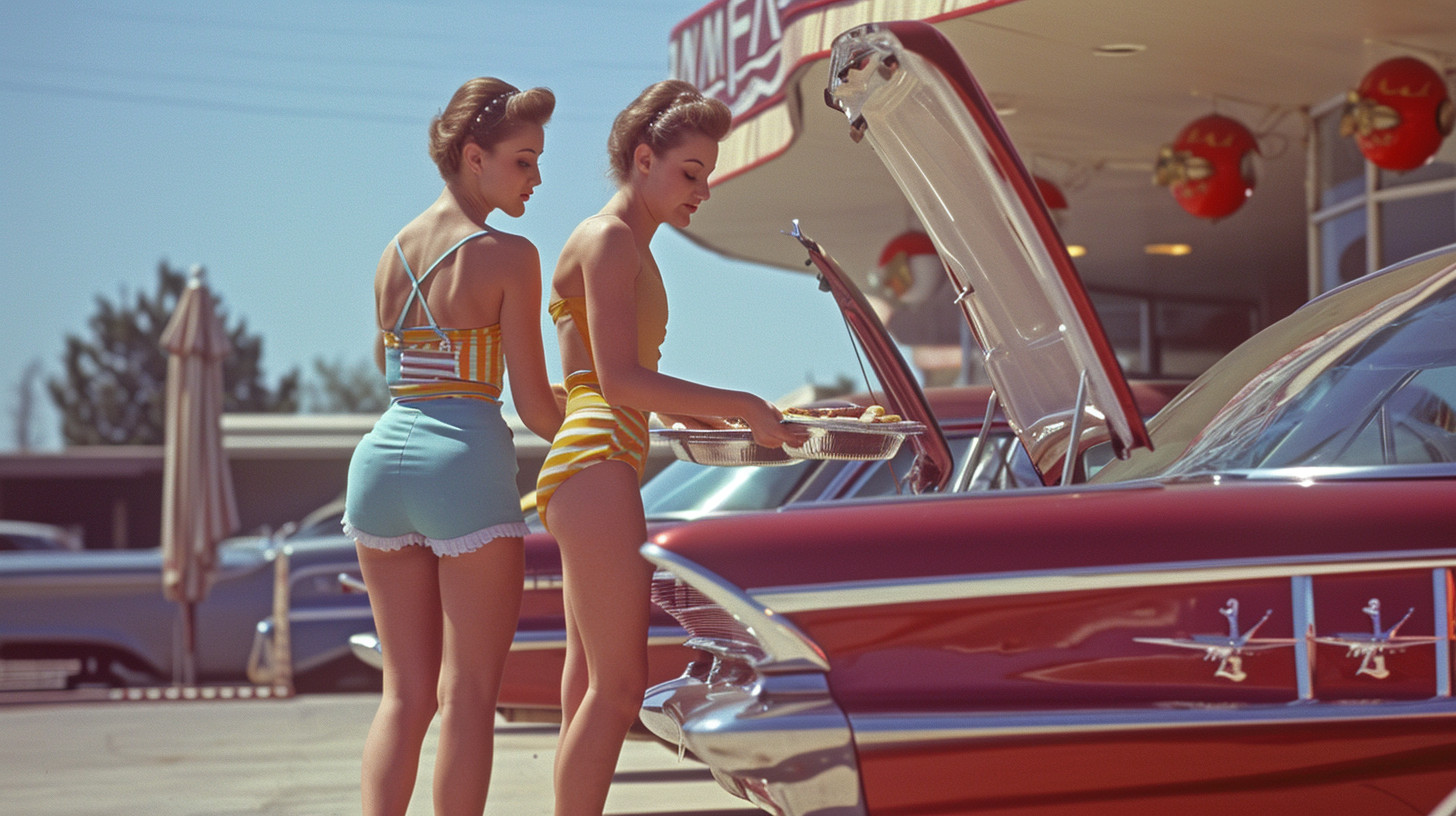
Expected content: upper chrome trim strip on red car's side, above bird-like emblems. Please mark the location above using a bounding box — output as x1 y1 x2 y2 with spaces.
748 549 1456 612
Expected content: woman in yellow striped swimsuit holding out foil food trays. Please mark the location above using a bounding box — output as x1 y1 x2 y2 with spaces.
536 80 805 816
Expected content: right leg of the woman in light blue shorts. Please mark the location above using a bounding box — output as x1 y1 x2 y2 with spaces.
435 538 526 816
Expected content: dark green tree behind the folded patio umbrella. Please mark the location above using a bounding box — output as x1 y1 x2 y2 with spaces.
47 261 298 444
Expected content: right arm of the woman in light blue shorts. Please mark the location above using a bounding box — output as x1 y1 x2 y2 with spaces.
501 239 562 442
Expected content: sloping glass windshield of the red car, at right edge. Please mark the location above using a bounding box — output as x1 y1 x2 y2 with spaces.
1166 276 1456 475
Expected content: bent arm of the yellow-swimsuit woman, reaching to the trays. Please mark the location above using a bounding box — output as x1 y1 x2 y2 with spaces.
581 219 807 447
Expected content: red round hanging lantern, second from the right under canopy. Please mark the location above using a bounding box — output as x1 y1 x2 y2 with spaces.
1153 114 1259 220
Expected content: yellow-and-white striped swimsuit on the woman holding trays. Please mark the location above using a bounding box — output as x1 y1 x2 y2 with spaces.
536 274 667 529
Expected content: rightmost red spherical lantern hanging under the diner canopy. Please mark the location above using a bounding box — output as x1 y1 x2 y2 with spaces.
1340 57 1456 170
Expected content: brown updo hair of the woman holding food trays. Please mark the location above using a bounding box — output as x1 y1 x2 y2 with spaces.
607 79 732 184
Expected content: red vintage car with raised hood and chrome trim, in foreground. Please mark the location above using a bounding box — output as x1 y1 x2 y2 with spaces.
642 23 1456 816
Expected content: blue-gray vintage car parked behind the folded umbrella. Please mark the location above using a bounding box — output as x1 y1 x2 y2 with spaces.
0 507 370 689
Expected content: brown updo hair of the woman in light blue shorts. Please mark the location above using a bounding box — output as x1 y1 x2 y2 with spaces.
430 77 556 181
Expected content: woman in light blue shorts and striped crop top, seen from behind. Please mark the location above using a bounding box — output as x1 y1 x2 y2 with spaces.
344 77 562 816
